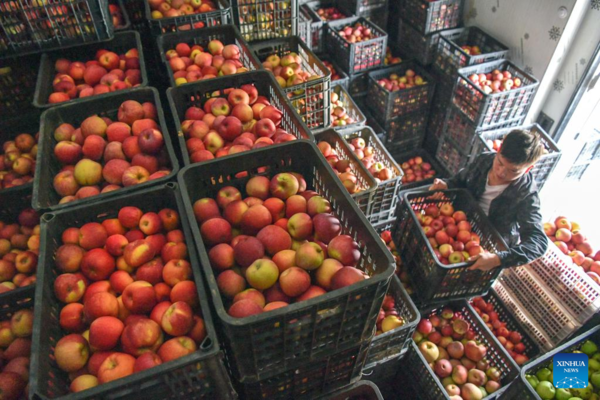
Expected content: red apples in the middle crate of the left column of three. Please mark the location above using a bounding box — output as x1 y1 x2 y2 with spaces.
53 100 171 204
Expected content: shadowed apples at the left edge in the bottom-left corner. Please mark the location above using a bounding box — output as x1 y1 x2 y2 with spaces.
0 309 33 400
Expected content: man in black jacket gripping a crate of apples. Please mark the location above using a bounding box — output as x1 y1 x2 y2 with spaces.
429 129 548 271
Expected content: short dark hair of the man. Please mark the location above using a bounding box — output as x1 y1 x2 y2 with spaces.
500 129 544 165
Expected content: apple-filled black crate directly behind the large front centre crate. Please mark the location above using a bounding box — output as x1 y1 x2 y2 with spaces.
167 71 313 164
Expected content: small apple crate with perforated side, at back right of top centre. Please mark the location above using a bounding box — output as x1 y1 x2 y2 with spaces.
325 17 387 75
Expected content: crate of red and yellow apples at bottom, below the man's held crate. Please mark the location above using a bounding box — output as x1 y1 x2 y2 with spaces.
404 300 519 400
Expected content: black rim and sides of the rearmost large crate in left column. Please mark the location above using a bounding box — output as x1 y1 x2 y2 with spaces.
33 31 148 109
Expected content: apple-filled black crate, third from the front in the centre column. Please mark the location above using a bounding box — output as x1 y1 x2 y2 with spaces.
158 25 260 86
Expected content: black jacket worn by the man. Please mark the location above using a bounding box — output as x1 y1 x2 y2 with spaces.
447 153 548 267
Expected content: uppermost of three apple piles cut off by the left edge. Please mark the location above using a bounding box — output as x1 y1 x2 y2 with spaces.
0 132 40 189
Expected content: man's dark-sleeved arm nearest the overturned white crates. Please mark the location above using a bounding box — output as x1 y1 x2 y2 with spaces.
497 193 548 267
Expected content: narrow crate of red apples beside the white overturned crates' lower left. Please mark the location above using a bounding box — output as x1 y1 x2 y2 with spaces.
470 290 541 366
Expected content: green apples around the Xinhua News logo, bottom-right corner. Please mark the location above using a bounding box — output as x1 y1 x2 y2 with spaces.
525 340 600 400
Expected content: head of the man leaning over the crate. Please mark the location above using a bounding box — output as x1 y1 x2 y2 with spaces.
494 129 544 183
